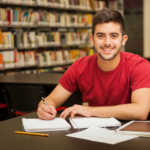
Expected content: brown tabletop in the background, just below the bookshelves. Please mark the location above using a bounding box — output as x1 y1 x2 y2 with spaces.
0 73 63 86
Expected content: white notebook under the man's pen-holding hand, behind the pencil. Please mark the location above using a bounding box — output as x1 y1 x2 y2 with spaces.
22 118 71 132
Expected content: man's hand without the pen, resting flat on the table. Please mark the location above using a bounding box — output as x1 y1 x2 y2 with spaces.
60 105 92 119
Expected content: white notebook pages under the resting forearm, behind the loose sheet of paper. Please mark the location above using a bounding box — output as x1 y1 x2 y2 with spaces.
69 116 121 129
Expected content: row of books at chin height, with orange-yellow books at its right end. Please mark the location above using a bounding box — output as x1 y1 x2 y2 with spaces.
0 49 94 68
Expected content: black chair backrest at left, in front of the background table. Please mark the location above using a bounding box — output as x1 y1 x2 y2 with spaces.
3 85 45 113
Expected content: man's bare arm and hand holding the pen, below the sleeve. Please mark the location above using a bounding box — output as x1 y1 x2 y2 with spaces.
37 84 72 120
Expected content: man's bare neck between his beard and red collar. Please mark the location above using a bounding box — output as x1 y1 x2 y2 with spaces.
97 52 121 71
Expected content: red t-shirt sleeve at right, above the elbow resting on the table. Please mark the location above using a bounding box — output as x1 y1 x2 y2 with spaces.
131 60 150 92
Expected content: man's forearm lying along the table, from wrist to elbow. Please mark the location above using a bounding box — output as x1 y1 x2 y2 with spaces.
91 103 149 120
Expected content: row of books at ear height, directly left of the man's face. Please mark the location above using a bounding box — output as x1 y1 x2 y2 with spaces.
0 30 91 49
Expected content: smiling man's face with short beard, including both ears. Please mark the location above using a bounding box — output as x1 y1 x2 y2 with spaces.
90 22 128 61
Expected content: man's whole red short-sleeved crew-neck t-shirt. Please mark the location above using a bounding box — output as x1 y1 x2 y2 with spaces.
59 52 150 106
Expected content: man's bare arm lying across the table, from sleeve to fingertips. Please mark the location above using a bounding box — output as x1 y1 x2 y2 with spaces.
60 88 150 120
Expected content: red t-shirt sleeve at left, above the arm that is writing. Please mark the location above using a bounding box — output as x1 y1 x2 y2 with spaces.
59 61 78 93
